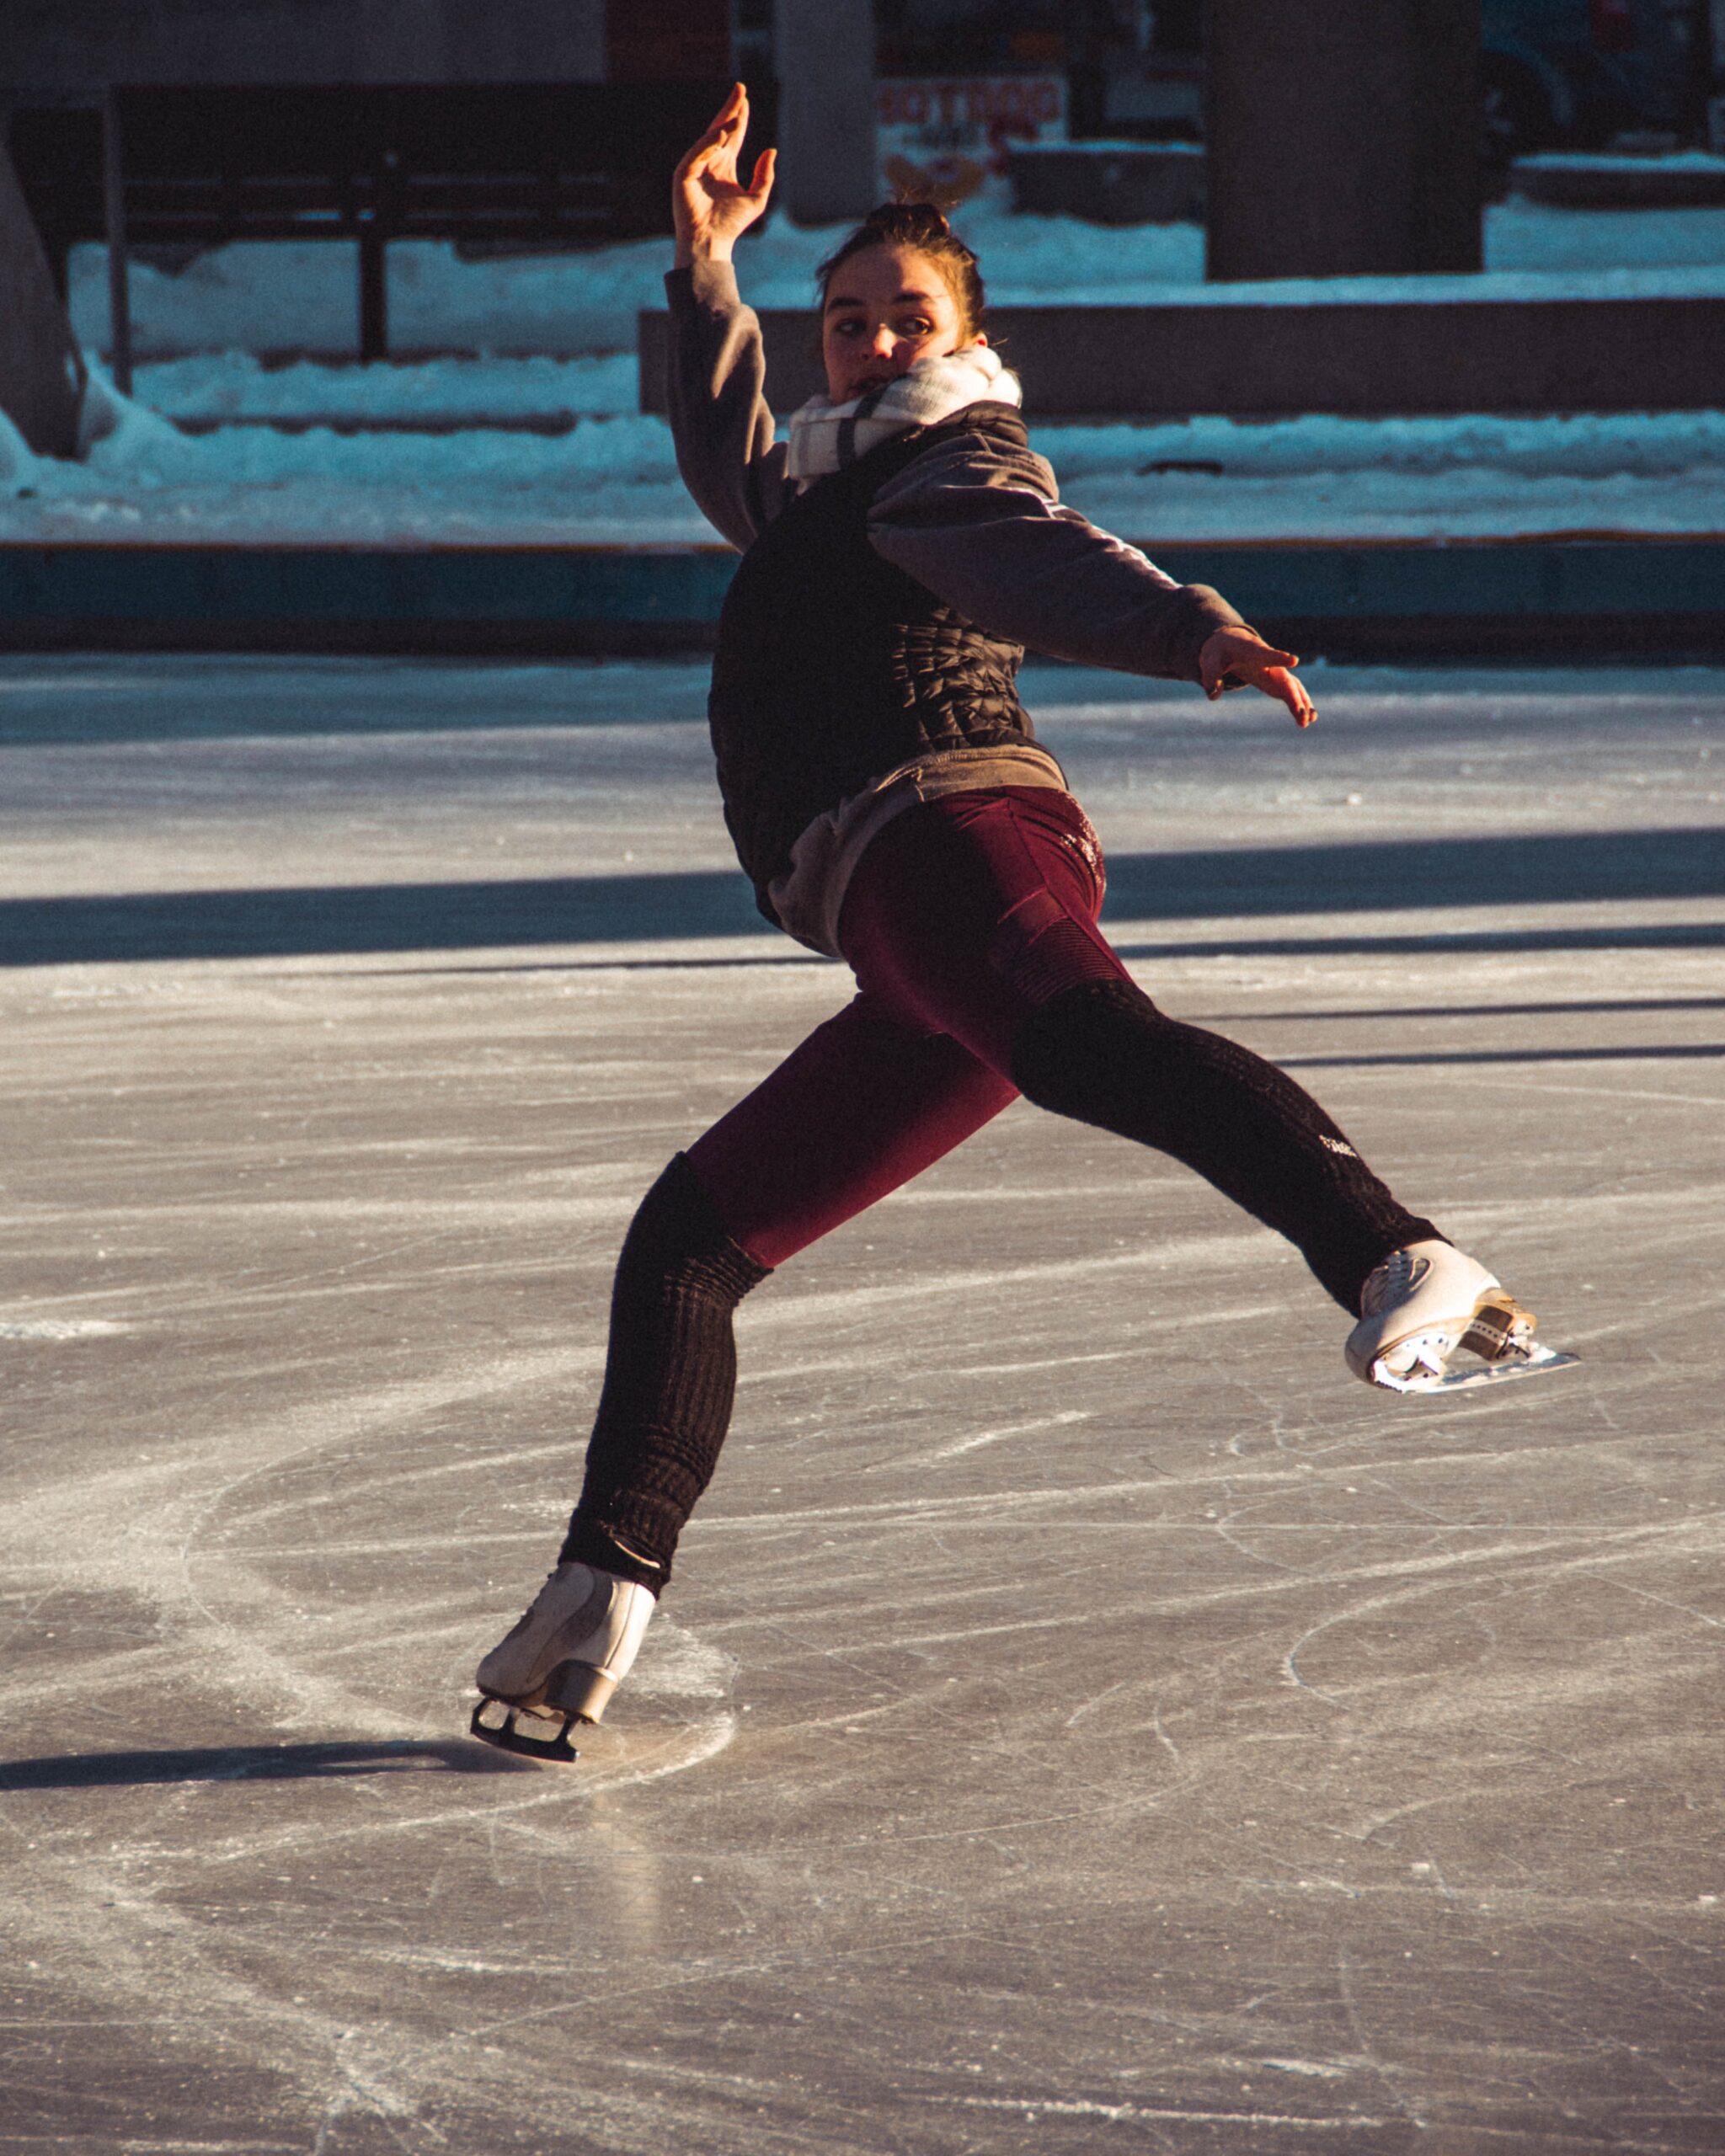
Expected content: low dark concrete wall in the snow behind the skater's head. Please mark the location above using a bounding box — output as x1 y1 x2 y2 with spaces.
636 297 1725 420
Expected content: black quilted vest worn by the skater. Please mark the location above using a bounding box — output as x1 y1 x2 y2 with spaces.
708 403 1033 921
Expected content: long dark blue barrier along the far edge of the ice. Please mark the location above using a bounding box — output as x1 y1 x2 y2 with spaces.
0 532 1725 658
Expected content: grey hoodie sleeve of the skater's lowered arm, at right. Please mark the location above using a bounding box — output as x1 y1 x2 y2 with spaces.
869 434 1240 681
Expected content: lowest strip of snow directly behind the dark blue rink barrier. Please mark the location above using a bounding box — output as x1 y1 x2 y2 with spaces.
0 382 1725 546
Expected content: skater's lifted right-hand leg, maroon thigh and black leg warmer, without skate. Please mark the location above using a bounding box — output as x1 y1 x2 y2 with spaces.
841 787 1440 1315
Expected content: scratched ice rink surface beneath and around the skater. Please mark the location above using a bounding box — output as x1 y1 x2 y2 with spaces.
0 658 1725 2156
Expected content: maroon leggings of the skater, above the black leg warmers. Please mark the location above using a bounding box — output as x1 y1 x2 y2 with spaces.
688 787 1130 1266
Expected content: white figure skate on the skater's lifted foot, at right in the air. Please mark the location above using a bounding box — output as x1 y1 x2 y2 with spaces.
1348 1242 1578 1393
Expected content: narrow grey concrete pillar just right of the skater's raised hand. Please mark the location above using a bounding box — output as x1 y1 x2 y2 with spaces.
772 0 879 224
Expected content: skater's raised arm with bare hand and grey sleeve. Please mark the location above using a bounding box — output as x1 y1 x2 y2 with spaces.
664 84 787 547
